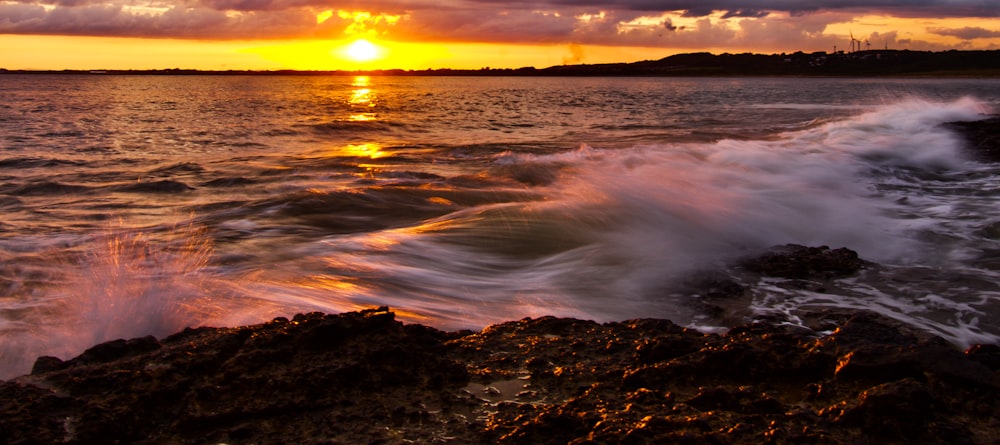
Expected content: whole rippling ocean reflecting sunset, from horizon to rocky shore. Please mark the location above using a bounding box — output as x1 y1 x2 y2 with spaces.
0 75 1000 378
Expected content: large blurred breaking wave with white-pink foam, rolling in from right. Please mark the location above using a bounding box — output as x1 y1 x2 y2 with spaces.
244 99 1000 329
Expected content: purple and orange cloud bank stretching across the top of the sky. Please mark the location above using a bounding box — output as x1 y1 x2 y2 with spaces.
0 0 1000 52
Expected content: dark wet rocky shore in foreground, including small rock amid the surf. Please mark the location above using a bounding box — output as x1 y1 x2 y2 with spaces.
0 246 1000 444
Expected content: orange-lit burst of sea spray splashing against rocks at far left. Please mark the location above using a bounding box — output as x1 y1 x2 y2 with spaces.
0 223 233 377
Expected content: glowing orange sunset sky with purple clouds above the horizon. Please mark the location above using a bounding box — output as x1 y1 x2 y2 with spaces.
0 0 1000 70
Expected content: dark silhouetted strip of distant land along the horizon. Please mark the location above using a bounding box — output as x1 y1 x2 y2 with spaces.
0 50 1000 77
